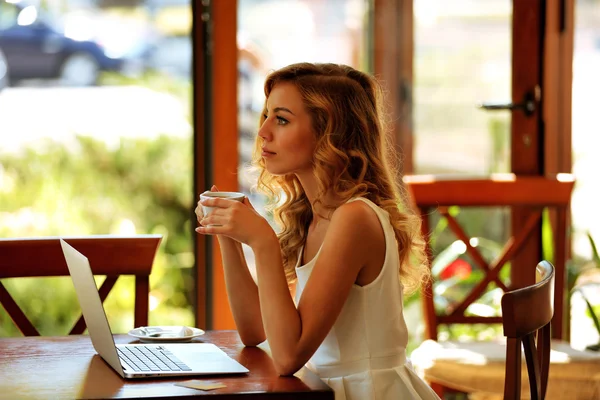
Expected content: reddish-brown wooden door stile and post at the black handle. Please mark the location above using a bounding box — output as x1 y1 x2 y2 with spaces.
511 0 574 339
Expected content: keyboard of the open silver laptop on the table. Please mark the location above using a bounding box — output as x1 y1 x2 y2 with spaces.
117 346 192 372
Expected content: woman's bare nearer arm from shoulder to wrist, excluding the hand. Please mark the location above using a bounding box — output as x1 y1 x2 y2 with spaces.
252 201 384 375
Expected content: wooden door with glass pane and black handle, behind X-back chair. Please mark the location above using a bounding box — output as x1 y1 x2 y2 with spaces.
398 0 572 338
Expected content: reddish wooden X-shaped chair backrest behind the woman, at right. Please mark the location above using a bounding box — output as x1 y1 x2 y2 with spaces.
404 174 575 340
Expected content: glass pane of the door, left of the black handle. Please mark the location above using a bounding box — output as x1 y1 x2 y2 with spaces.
413 0 512 340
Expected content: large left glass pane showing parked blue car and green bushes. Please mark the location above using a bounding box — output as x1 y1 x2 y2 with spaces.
0 0 194 336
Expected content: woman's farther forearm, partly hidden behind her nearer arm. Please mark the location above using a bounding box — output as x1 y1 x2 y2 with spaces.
218 235 265 346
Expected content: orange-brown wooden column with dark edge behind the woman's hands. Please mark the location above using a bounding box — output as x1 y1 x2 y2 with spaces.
192 0 238 329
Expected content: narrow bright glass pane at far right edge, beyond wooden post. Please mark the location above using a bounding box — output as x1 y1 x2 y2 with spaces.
571 0 600 349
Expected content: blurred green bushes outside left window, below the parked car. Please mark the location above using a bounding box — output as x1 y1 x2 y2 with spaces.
0 135 194 336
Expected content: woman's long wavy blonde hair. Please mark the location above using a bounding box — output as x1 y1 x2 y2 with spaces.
252 63 429 292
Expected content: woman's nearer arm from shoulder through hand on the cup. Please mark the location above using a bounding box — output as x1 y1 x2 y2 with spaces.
196 198 384 375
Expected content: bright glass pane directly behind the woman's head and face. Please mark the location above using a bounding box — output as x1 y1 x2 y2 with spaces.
237 0 371 269
